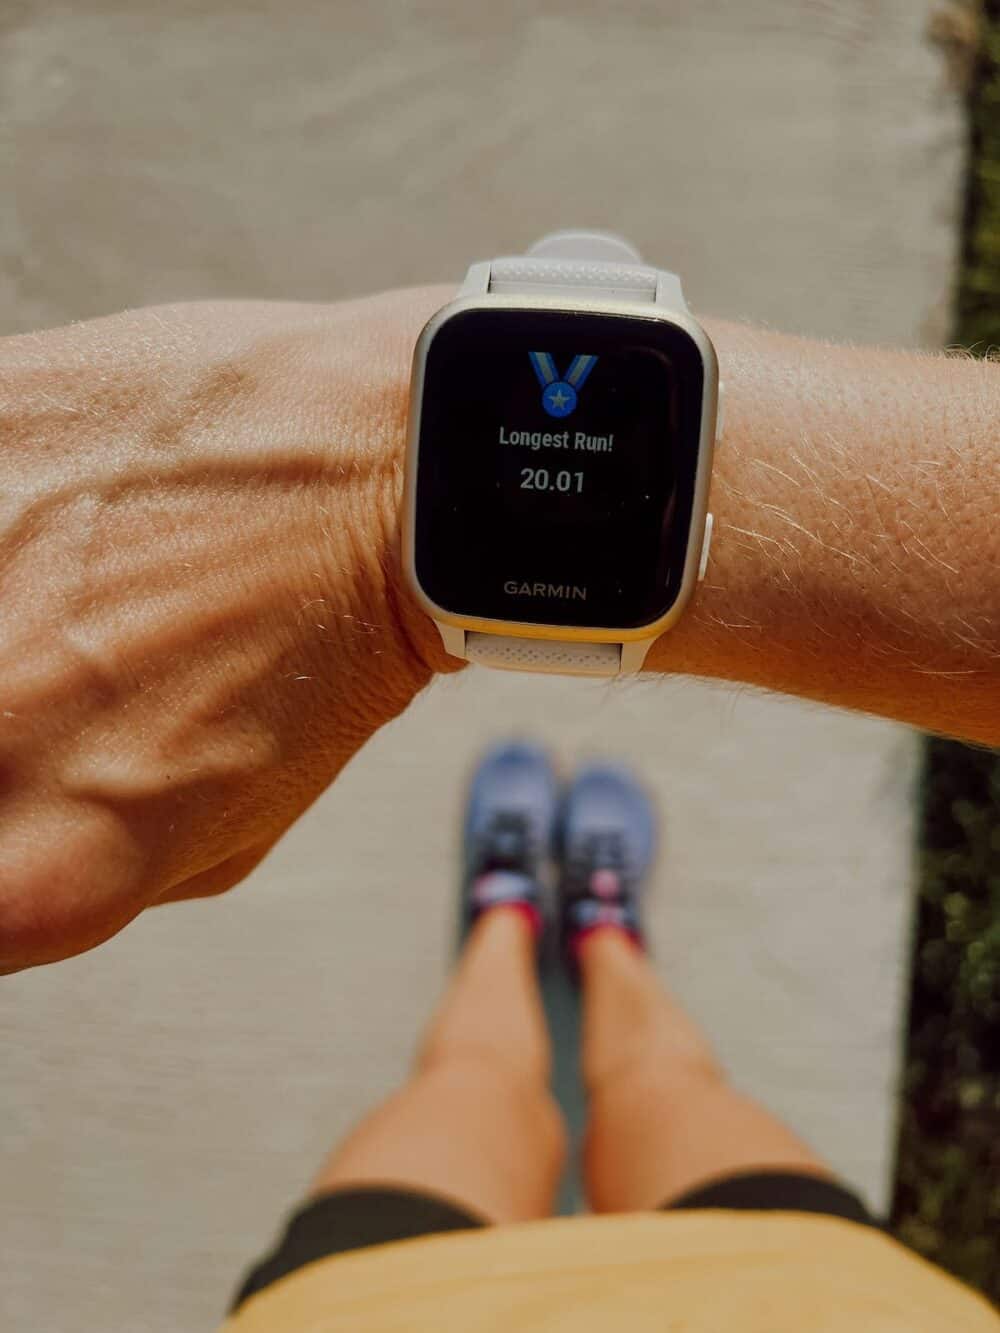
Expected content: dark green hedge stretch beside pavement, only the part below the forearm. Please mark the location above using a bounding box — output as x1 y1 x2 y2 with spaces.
892 740 1000 1300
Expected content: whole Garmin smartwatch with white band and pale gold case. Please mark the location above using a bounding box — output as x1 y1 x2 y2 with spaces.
403 232 721 676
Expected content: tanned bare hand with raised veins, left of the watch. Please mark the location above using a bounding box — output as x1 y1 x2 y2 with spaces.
0 291 455 972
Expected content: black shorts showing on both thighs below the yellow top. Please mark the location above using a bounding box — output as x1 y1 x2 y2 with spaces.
232 1172 879 1310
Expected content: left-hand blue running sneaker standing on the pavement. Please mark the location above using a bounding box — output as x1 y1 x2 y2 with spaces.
463 742 559 937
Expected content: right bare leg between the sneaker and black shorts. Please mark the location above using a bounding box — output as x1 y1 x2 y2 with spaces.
579 929 832 1212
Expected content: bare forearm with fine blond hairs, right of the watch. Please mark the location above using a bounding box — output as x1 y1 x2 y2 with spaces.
649 323 1000 744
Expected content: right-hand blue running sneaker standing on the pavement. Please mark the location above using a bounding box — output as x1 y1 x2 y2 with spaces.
559 764 656 976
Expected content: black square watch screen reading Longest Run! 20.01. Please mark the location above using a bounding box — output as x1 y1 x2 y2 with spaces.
415 309 704 629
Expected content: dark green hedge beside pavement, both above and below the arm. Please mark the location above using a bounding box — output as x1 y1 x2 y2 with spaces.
892 0 1000 1301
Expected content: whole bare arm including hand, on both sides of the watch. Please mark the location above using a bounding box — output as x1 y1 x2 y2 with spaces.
0 289 1000 970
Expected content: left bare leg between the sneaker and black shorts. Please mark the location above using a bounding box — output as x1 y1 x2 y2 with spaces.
313 908 565 1222
